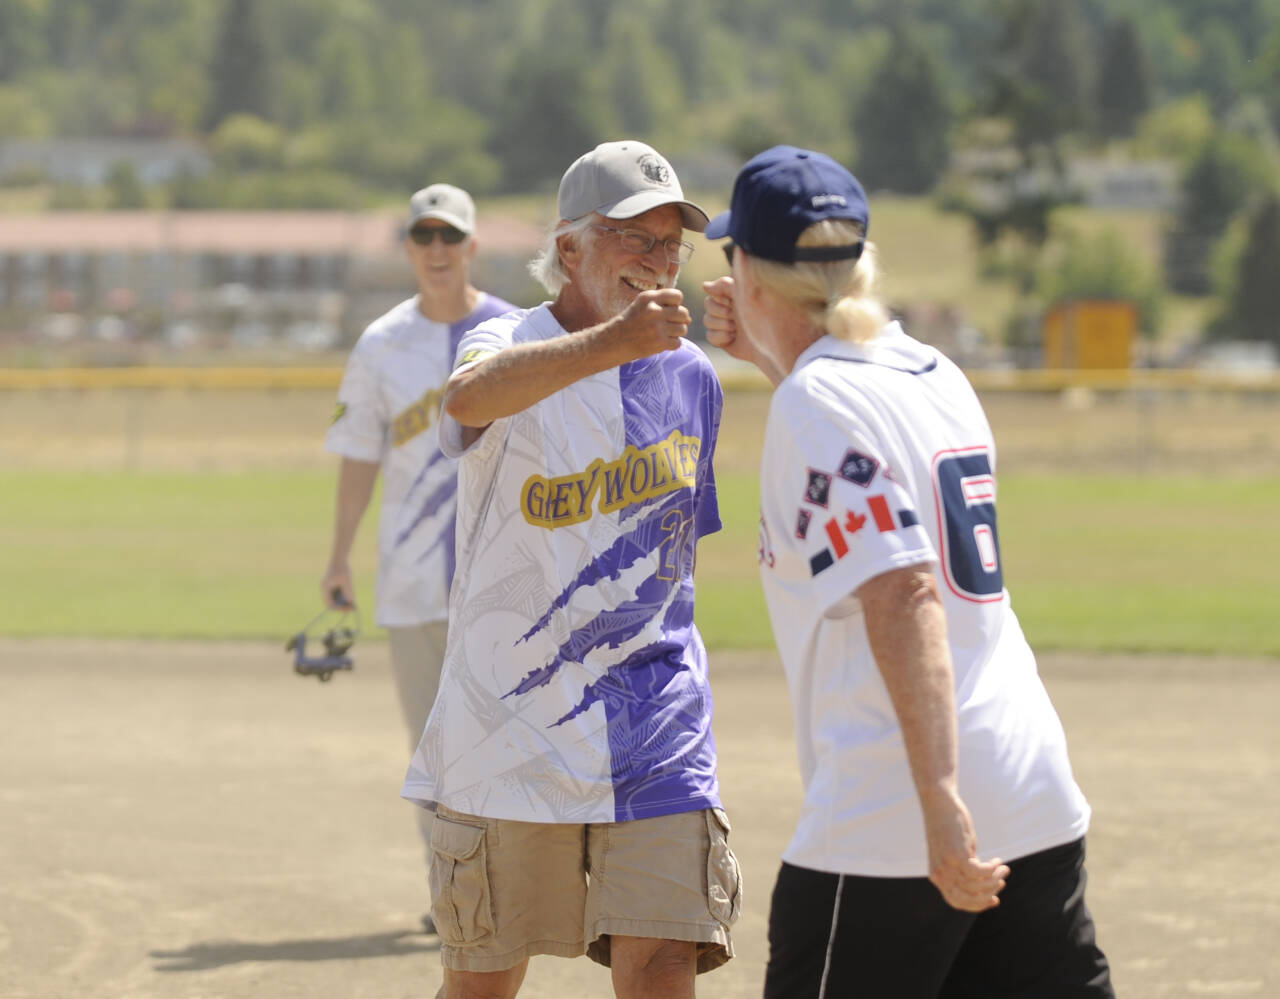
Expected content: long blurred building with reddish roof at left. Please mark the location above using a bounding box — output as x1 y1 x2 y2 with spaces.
0 211 541 347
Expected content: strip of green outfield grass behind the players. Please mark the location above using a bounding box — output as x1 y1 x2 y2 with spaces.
0 470 1280 657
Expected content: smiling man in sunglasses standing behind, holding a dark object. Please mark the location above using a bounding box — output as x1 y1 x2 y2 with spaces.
320 178 515 932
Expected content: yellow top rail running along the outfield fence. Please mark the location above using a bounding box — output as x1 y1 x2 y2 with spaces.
0 365 1280 393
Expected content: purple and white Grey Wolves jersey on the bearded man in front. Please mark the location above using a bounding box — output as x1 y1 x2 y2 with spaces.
403 305 722 822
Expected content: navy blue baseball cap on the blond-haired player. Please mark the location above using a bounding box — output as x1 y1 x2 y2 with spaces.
705 146 870 264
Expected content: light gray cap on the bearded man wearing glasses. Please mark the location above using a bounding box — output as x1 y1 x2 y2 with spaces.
558 138 708 232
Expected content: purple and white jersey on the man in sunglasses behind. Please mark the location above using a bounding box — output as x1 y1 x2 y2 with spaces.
325 292 515 628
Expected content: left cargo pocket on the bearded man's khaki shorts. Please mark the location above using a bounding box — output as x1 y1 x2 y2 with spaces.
430 815 494 946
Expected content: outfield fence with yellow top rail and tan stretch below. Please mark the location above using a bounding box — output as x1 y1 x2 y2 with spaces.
0 362 1280 476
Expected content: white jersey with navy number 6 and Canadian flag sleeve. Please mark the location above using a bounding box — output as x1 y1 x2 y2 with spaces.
759 323 1089 877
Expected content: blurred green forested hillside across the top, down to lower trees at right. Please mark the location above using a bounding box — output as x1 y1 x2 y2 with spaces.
0 0 1280 342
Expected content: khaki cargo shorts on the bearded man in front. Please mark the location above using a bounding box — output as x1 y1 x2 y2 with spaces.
431 806 742 972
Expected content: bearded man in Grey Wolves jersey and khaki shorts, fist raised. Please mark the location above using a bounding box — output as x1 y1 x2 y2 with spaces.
404 141 740 999
